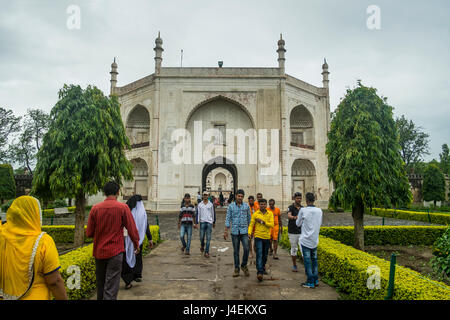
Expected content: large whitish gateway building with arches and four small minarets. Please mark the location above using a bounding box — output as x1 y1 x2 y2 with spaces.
110 34 331 212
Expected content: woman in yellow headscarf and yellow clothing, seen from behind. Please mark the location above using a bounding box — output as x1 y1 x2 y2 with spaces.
0 196 67 300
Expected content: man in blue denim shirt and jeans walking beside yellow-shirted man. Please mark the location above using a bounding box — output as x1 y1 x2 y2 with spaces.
223 189 251 277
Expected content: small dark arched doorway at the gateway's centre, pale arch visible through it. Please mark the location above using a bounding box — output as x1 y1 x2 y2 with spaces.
202 157 238 196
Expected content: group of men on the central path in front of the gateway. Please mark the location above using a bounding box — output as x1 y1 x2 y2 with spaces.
178 189 322 288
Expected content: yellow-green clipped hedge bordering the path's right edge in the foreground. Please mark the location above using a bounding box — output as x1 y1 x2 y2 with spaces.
280 227 450 300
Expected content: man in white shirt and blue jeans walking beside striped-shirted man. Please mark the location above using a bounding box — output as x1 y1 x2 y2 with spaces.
196 192 216 258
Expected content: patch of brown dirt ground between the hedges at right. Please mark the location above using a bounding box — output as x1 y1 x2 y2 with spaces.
365 245 450 285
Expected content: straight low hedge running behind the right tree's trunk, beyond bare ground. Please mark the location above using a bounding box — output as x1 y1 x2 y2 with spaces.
320 226 447 246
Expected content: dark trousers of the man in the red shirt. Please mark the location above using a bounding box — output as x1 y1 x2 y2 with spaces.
95 252 125 300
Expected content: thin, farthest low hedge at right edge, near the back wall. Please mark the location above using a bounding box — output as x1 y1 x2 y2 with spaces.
365 208 450 225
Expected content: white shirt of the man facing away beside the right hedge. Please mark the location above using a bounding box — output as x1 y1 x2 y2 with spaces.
296 206 322 249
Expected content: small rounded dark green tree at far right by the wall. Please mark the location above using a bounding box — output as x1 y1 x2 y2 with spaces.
422 162 445 206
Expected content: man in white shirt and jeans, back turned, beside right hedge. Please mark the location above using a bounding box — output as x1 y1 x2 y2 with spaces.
296 192 322 289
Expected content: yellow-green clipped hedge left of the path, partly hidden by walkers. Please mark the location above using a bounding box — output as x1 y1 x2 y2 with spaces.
47 226 160 300
